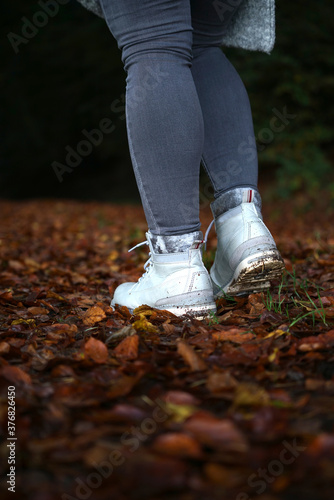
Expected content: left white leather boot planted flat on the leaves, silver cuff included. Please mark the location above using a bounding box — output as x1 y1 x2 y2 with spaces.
111 231 216 317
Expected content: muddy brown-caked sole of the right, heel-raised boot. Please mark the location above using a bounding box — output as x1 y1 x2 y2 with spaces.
210 250 285 298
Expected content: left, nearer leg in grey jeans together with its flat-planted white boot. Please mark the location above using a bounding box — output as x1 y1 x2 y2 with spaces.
101 0 216 317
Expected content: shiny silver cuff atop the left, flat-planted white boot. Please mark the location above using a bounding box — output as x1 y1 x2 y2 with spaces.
146 231 203 254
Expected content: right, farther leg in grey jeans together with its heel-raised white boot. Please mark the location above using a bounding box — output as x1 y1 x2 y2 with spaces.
191 0 284 296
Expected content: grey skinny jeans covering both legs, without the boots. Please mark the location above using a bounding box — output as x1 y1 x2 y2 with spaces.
100 0 258 236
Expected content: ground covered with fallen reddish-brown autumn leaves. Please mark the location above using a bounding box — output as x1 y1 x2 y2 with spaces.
0 199 334 500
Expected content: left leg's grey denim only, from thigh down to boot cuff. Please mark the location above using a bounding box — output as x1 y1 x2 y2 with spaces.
101 0 204 235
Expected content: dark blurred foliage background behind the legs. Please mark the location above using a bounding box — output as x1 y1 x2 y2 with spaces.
0 0 334 201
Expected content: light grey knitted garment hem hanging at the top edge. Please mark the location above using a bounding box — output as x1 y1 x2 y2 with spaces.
78 0 275 54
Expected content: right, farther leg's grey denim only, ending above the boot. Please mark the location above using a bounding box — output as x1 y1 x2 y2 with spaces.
191 0 258 198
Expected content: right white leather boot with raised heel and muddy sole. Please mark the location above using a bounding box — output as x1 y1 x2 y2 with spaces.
210 188 284 297
